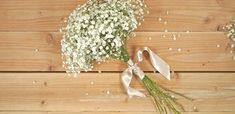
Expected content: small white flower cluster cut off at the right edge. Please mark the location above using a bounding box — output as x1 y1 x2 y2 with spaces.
223 20 235 60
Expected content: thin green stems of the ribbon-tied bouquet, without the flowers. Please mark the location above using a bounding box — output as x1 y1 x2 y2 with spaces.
123 49 193 114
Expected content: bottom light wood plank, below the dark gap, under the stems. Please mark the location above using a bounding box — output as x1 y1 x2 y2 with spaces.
0 73 235 114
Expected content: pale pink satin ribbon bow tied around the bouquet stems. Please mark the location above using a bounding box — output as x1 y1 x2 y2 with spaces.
121 47 171 97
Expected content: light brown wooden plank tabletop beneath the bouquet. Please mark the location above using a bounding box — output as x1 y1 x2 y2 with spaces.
0 0 235 114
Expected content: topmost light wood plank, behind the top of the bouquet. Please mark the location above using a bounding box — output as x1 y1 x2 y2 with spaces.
0 0 235 32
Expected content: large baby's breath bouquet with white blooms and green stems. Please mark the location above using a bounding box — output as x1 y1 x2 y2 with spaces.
61 0 189 114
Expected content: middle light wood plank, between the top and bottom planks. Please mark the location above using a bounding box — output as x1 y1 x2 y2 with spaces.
0 32 235 71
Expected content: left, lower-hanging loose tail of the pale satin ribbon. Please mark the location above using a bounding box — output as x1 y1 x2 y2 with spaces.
121 68 145 97
